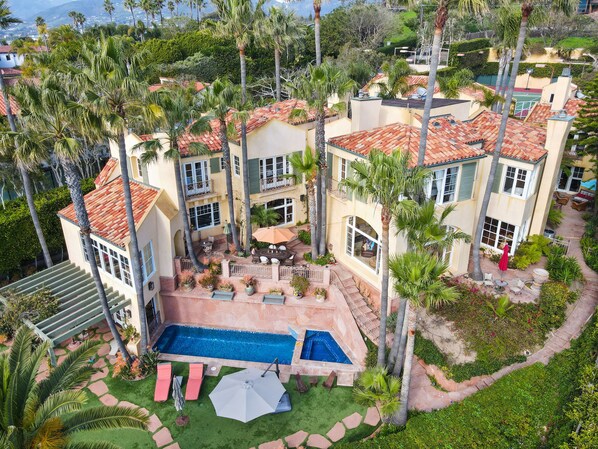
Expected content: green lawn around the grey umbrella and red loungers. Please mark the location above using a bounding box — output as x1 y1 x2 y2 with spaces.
90 363 374 449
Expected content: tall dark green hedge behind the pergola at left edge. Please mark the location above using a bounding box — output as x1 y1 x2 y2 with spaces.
0 179 94 274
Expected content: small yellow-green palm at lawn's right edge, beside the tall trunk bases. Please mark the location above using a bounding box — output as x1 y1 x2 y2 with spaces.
353 367 401 421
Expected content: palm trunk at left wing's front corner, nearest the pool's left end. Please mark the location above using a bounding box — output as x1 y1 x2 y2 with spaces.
117 131 149 355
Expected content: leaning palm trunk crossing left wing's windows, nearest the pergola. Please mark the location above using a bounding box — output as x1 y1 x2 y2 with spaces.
62 161 132 363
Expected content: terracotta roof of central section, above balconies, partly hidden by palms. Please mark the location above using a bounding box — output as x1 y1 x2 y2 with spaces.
179 99 336 155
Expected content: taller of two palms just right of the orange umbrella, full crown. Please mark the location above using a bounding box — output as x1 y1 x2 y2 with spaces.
288 64 356 255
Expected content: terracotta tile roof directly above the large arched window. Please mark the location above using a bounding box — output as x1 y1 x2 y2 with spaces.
329 123 484 165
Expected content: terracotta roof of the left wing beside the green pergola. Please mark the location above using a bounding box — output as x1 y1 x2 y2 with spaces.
58 177 160 247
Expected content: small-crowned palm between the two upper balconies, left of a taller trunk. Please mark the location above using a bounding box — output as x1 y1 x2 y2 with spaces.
199 79 241 251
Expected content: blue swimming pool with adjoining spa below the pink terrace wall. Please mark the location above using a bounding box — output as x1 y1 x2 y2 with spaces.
155 324 351 365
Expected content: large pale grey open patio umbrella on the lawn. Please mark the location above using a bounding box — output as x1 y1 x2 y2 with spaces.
210 368 285 422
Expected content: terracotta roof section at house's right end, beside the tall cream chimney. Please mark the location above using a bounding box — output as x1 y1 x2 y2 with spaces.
468 111 546 162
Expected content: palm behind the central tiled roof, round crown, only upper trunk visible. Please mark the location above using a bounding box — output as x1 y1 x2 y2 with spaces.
258 6 305 101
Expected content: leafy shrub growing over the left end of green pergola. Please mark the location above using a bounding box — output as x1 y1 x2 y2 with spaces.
0 288 60 338
